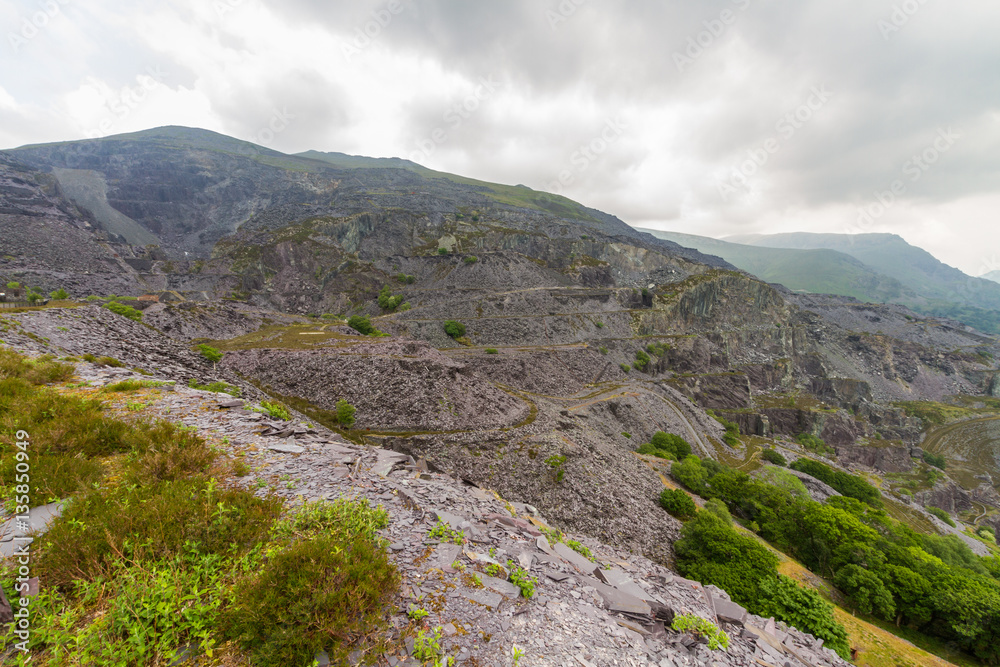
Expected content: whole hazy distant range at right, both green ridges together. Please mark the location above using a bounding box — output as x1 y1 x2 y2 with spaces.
643 229 1000 333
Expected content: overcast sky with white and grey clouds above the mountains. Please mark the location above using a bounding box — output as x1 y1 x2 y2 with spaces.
0 0 1000 275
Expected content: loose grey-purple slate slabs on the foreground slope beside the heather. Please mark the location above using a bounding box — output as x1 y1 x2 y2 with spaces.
0 350 849 667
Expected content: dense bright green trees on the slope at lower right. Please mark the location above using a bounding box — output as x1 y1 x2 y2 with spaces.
672 456 1000 665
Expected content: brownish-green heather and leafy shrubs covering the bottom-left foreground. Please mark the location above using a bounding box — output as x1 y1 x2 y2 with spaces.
0 350 399 667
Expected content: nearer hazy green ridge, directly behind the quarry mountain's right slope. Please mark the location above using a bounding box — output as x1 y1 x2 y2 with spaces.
640 229 917 303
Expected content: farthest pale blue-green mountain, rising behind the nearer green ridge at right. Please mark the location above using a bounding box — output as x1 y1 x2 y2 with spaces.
724 232 1000 333
